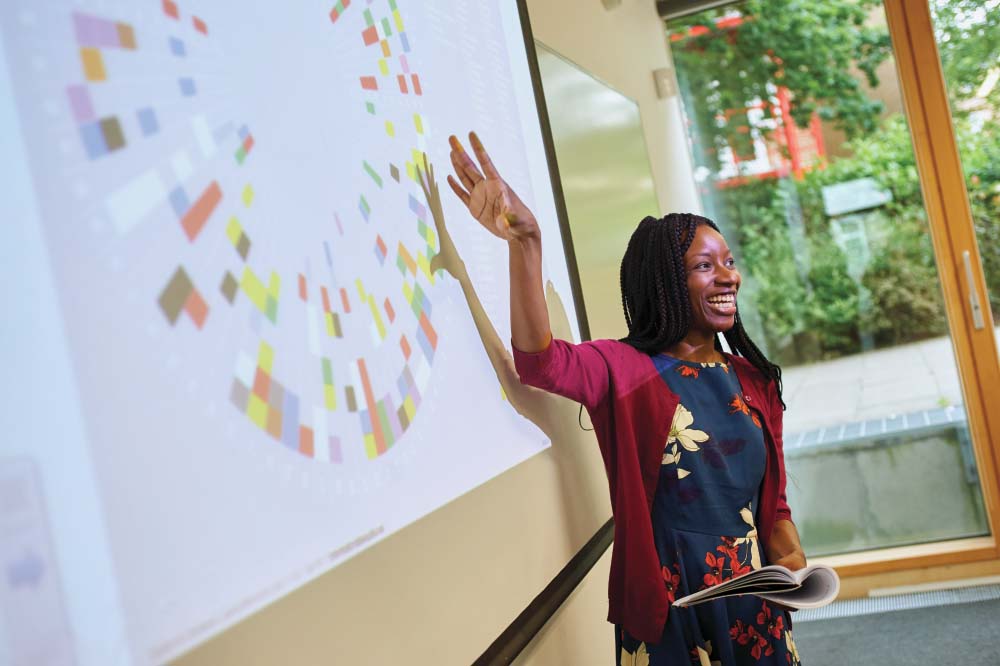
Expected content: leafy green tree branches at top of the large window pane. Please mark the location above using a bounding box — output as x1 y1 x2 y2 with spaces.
668 0 890 171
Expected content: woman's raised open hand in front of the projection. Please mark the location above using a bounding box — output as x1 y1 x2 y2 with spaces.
448 132 539 241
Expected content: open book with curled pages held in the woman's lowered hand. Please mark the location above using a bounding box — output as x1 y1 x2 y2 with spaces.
674 564 840 608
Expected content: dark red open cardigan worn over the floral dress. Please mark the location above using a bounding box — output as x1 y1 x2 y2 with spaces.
514 340 791 643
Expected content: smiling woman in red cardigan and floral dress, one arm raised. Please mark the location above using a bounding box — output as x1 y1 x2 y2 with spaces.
448 134 806 666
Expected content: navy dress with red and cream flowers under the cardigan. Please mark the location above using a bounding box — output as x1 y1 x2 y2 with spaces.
615 354 800 666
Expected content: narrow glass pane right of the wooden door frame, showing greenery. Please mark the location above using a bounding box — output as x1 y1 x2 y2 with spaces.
930 0 1000 330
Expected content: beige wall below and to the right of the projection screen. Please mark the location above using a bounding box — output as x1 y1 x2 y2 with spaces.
178 0 698 666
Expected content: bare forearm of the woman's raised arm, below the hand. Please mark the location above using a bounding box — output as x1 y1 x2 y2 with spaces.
508 234 552 352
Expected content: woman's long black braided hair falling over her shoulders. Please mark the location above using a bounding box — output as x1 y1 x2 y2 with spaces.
620 213 785 408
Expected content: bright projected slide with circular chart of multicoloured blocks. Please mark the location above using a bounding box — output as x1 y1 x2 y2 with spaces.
0 0 573 661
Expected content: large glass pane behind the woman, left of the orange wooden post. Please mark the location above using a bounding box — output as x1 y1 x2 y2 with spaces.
668 0 988 556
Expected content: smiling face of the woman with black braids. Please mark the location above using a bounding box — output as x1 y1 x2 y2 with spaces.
684 224 740 336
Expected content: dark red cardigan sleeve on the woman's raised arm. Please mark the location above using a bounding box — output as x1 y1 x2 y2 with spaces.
511 339 610 410
